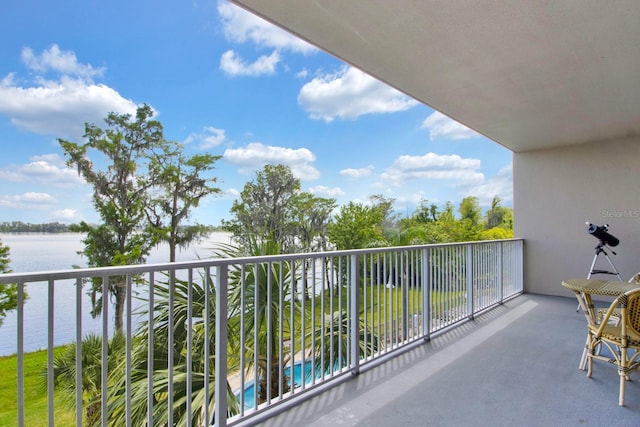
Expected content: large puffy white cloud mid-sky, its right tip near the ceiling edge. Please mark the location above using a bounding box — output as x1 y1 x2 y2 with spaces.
298 67 418 122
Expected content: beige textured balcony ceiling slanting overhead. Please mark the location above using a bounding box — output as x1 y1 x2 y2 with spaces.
233 0 640 152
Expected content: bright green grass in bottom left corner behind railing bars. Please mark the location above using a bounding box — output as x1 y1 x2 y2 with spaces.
0 347 75 426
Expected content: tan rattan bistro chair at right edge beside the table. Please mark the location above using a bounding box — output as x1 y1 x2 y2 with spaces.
587 288 640 406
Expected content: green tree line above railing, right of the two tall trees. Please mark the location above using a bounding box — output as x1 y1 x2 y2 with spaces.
223 165 513 253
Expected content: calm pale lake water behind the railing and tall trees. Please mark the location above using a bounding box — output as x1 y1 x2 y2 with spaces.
0 232 231 356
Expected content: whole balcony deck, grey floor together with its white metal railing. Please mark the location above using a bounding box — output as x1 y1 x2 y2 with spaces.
0 240 640 426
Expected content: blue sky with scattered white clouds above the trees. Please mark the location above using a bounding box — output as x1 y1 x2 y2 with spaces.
0 0 512 224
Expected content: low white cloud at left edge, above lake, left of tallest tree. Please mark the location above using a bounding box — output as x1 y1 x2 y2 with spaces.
0 154 85 187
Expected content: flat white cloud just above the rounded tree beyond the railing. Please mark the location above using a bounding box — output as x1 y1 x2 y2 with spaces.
224 142 320 180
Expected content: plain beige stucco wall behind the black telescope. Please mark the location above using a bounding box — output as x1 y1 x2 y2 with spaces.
513 137 640 295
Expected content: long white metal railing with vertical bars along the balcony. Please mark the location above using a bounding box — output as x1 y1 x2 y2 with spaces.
0 239 523 426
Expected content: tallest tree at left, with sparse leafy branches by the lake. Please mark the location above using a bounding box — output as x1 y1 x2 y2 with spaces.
58 105 165 331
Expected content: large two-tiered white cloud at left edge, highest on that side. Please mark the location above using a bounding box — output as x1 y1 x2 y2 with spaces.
0 45 137 139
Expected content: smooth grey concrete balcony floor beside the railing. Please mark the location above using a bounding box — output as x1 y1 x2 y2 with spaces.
238 294 640 426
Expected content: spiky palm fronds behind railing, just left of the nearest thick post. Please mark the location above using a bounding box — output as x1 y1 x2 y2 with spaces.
108 277 239 426
